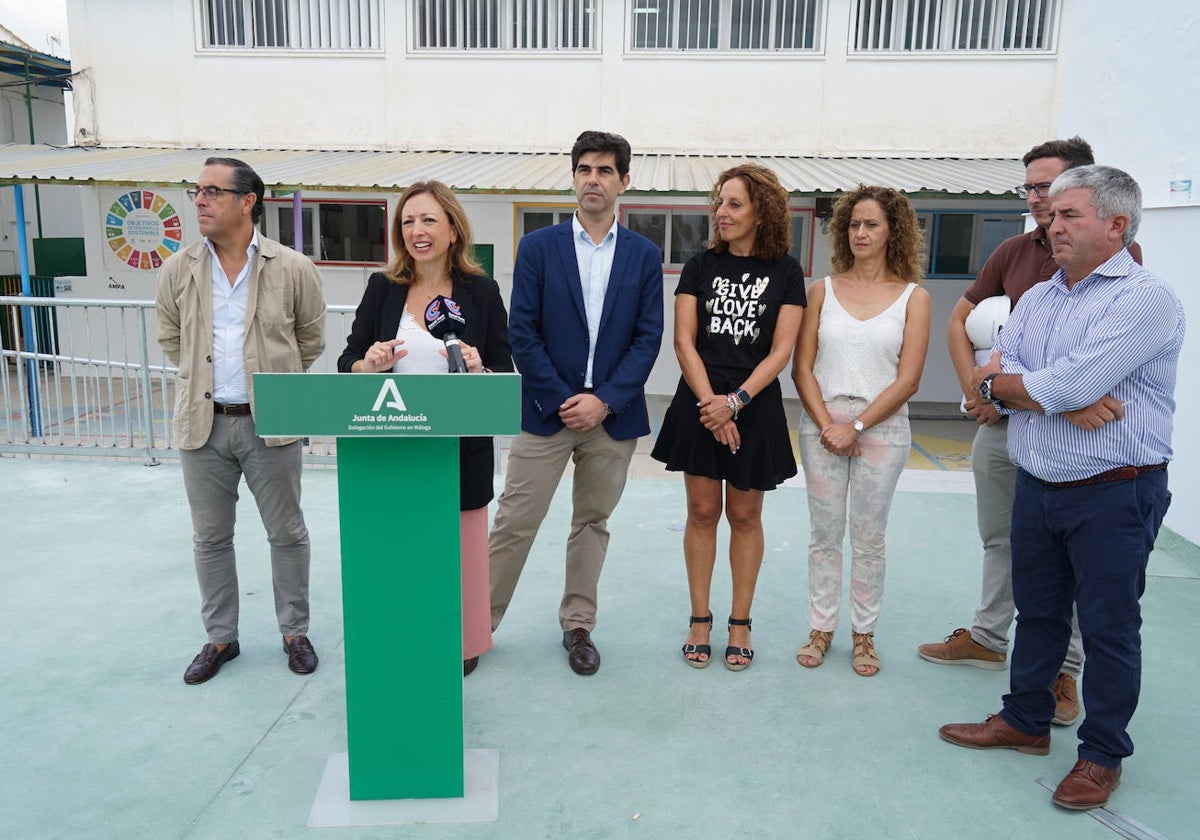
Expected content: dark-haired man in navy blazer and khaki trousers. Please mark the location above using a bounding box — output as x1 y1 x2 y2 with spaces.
488 131 662 674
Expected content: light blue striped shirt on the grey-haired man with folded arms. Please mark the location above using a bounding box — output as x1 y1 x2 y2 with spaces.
996 250 1184 481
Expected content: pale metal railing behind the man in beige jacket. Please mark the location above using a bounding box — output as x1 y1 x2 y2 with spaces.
0 295 354 466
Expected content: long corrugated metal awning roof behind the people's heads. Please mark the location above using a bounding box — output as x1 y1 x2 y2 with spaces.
0 145 1025 196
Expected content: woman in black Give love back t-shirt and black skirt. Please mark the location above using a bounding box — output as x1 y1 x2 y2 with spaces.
653 163 805 671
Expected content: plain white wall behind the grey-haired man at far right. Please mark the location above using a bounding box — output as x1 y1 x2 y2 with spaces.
1058 0 1200 542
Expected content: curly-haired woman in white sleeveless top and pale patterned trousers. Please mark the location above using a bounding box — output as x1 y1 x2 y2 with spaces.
792 186 930 677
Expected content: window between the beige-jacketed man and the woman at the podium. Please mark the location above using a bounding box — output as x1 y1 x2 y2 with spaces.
259 198 388 265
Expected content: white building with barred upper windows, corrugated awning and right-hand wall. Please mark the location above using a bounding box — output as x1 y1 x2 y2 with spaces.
0 0 1200 541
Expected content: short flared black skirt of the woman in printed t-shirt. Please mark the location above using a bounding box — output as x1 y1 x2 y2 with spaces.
650 377 796 490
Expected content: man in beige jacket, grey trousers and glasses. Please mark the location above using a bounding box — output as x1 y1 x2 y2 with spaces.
157 157 325 685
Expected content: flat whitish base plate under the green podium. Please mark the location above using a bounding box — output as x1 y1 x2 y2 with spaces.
308 750 500 828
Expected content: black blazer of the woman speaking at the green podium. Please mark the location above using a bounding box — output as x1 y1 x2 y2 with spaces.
337 271 514 510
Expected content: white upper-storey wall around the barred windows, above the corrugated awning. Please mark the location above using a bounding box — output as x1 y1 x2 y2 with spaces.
68 0 1069 156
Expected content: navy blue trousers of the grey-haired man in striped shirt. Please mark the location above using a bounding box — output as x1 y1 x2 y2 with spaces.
1001 469 1171 767
